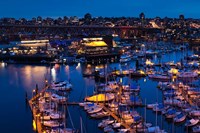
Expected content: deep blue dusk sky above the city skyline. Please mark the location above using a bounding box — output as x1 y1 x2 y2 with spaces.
0 0 200 18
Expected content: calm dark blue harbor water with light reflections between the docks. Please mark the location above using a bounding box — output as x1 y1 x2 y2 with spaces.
0 47 198 133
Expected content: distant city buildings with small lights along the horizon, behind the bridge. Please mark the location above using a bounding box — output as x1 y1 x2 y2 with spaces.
0 13 200 43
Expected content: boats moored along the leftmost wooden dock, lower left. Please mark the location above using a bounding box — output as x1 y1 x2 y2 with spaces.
32 81 77 133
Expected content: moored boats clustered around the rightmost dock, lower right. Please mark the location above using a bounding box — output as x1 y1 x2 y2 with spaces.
147 82 200 133
